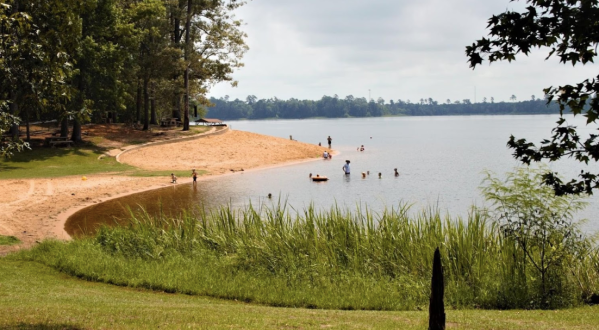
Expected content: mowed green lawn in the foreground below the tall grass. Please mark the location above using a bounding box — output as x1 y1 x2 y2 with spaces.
0 259 599 330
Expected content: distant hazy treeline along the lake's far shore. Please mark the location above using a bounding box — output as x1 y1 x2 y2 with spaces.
207 95 559 120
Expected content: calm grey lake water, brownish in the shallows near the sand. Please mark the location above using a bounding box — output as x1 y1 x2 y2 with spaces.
67 115 599 234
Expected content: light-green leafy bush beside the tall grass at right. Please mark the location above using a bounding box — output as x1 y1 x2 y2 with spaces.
482 168 591 308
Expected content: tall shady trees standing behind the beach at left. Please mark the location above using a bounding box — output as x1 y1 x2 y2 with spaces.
0 0 248 144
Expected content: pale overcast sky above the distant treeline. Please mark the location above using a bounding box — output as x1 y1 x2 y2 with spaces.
209 0 597 102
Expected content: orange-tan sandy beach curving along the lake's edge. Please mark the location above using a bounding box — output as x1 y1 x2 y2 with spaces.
0 130 326 254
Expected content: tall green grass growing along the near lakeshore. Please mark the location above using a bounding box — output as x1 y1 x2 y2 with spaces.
17 204 599 310
